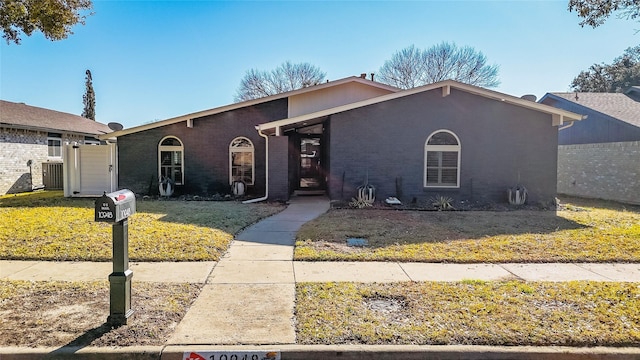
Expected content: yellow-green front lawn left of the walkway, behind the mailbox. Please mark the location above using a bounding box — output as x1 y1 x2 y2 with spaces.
0 191 284 261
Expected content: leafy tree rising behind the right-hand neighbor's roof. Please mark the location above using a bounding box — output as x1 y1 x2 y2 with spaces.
571 45 640 92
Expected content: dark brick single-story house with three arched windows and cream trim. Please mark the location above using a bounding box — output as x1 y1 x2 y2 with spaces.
101 77 581 203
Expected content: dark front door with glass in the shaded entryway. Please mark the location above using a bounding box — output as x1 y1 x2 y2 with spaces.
299 134 325 190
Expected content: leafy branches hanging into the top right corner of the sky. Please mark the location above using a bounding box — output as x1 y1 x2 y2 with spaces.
569 0 640 28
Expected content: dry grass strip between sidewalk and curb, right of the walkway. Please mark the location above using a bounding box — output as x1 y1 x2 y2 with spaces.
296 281 640 346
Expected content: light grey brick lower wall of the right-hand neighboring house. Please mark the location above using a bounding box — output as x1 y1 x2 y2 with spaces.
558 141 640 204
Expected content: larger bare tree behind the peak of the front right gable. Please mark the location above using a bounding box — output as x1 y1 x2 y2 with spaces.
378 42 500 89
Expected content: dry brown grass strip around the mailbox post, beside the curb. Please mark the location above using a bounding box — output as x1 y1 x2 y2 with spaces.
0 280 202 347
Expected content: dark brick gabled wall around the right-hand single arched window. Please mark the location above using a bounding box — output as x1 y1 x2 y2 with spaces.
329 89 558 204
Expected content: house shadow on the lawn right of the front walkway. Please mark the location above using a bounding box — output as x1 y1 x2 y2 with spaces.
297 209 589 249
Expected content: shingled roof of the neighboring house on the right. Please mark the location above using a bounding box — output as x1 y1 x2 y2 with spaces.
540 91 640 127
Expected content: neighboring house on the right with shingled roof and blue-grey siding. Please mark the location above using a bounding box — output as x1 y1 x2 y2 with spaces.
540 86 640 204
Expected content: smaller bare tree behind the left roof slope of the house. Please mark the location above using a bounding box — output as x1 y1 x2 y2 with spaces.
235 61 326 102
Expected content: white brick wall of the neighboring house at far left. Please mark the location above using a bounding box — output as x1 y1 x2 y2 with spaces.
0 127 83 195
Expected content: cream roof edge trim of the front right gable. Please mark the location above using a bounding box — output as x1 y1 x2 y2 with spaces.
256 80 583 130
